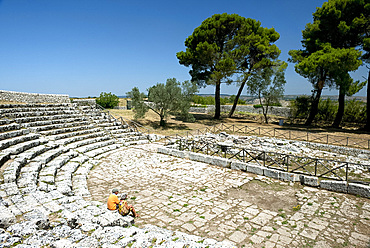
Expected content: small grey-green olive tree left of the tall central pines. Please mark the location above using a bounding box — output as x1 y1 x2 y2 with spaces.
127 78 198 126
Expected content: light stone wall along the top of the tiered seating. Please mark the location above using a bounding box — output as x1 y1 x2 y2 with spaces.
0 90 71 103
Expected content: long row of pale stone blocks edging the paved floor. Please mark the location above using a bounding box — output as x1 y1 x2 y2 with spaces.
158 147 370 198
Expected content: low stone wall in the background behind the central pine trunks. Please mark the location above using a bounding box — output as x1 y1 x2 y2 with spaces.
189 105 291 118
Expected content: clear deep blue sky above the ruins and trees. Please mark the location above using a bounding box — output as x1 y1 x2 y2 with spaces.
0 0 367 97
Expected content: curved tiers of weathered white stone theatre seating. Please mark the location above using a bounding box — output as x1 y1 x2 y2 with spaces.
0 91 231 247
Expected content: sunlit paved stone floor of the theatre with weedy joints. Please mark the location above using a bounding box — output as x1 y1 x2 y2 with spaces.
88 144 370 248
